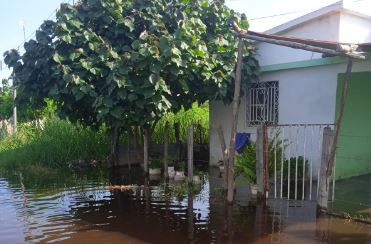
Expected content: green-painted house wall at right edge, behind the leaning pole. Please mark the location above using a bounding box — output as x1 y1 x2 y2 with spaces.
336 69 371 179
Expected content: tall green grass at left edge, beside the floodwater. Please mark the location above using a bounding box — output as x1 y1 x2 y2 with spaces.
0 119 109 169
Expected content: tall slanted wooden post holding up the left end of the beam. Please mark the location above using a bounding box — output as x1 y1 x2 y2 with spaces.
227 38 244 203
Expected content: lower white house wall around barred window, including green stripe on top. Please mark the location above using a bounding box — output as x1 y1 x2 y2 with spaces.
210 60 371 178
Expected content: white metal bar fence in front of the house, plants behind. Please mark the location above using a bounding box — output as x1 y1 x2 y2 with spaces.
267 124 334 200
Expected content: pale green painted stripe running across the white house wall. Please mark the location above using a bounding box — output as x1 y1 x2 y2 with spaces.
260 53 371 73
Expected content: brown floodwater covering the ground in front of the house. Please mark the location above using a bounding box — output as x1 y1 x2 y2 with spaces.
0 167 371 244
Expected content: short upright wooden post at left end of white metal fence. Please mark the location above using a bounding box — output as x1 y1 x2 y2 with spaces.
256 125 265 198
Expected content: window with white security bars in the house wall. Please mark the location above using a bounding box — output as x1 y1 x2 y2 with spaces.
246 81 279 125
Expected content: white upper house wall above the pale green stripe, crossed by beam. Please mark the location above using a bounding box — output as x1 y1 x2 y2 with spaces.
257 12 371 66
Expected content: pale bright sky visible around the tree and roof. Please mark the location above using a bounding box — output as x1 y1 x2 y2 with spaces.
0 0 371 79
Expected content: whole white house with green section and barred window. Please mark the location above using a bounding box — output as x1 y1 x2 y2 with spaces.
210 1 371 178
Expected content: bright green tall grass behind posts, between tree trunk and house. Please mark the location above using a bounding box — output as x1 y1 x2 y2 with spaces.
152 102 209 144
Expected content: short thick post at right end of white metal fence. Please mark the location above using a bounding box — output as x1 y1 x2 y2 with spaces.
317 127 334 210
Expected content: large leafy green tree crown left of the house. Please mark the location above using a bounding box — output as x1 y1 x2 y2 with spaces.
5 0 257 164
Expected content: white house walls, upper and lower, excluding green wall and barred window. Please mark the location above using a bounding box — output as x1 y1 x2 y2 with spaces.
210 8 371 178
